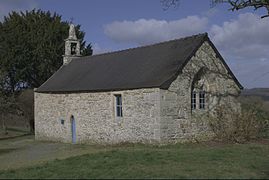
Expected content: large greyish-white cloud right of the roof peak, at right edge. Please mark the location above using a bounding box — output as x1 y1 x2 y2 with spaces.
210 13 269 59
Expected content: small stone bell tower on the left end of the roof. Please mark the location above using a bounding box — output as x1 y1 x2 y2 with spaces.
63 24 81 65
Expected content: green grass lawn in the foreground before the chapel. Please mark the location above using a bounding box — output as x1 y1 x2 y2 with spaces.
0 143 269 178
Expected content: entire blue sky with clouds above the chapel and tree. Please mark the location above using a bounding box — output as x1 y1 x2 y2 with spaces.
0 0 269 88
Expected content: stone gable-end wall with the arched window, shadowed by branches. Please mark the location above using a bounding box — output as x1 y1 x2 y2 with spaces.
161 42 240 142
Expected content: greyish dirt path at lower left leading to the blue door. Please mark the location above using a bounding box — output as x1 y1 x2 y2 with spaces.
0 136 105 170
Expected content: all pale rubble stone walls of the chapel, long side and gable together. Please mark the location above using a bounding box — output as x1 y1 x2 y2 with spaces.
35 42 240 144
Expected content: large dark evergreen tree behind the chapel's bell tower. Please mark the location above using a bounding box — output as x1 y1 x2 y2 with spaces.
0 10 92 93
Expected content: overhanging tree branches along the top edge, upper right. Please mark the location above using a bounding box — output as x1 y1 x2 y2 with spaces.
161 0 269 18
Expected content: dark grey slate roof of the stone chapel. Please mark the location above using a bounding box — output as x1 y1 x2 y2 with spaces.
36 33 242 93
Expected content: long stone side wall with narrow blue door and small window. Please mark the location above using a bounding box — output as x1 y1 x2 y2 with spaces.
35 88 160 144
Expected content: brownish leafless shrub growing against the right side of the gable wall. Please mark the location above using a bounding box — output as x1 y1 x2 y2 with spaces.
209 97 269 143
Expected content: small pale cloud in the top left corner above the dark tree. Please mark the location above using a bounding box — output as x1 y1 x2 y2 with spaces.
0 0 38 20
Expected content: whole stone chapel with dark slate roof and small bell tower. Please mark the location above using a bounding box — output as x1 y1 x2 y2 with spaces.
34 24 243 144
